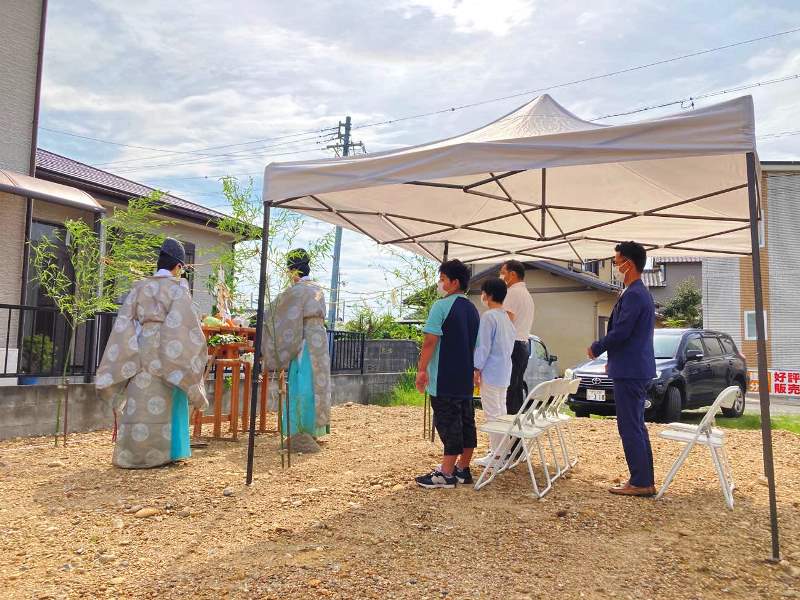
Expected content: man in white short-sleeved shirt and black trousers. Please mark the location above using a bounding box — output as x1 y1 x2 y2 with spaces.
500 260 534 415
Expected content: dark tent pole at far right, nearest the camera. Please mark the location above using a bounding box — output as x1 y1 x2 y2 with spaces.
747 152 780 561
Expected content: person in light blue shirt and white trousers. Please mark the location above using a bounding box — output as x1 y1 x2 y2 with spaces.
473 277 516 467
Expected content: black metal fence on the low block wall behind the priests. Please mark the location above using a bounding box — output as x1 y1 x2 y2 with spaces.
0 304 365 383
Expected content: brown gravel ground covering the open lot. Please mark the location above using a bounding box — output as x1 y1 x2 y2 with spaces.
0 406 800 600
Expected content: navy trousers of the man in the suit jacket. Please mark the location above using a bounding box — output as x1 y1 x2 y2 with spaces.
614 379 655 487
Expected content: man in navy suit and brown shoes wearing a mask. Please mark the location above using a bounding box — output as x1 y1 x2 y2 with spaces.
587 242 656 496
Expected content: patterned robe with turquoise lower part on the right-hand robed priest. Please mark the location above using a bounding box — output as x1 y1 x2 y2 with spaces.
261 278 331 435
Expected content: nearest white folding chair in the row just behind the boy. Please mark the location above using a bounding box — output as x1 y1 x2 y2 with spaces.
475 381 553 498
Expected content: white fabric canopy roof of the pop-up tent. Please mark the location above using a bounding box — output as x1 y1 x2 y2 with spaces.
264 95 756 262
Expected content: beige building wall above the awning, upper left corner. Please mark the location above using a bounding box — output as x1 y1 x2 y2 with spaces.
0 0 42 174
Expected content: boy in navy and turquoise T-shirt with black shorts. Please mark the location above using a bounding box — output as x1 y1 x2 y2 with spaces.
415 260 480 489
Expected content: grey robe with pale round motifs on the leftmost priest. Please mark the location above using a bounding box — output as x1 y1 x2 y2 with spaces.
95 277 208 469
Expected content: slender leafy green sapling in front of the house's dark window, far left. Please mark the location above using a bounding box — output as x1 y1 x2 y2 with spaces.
31 219 116 445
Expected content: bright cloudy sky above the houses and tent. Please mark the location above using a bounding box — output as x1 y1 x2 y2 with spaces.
40 0 800 312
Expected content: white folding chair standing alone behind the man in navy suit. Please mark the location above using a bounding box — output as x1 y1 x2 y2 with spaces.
656 385 742 509
